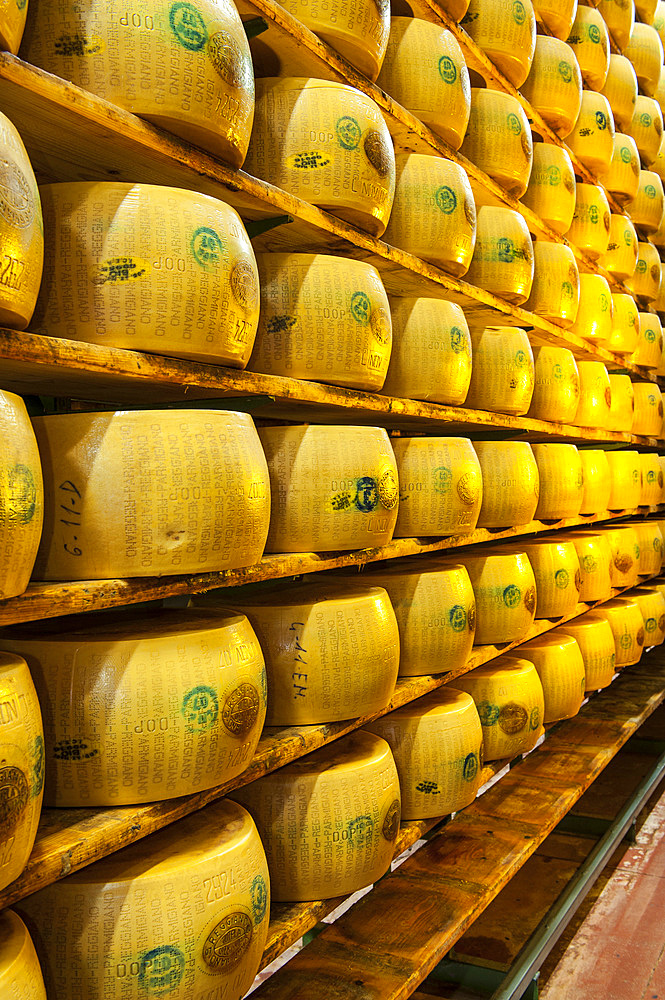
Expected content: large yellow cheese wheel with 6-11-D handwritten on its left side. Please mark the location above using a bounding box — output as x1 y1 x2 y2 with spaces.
33 409 270 580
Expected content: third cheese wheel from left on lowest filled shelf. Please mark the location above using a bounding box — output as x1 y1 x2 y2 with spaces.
233 730 400 902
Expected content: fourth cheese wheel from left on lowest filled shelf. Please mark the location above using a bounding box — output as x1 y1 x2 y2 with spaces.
366 687 483 820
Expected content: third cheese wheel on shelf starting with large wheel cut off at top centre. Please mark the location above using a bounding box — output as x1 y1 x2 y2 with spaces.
461 87 533 198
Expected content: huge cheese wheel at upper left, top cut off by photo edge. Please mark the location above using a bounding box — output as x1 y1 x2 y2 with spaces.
22 0 254 167
